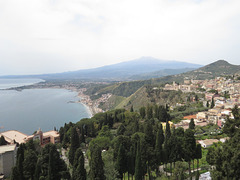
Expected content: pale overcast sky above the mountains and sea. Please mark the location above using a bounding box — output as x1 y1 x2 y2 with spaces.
0 0 240 75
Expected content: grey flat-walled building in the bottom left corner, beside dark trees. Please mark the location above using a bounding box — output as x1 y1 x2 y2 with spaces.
0 144 17 177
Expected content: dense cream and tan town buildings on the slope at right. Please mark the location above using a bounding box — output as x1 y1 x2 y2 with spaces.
170 77 240 148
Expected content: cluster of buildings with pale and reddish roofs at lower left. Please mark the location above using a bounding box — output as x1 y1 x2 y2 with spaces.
0 129 60 179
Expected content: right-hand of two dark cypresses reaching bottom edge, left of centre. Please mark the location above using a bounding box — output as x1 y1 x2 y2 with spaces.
89 144 106 180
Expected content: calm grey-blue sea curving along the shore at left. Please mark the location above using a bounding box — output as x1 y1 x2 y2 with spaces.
0 79 91 135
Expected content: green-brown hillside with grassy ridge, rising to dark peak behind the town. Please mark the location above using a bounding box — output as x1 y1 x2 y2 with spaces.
95 60 240 109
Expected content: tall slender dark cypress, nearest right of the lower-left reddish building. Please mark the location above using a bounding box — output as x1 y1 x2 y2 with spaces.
68 128 80 165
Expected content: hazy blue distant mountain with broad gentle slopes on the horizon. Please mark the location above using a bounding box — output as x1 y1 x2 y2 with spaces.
1 57 201 81
